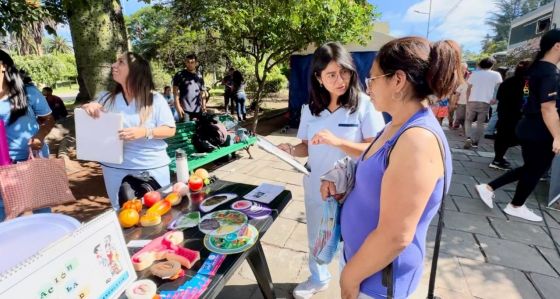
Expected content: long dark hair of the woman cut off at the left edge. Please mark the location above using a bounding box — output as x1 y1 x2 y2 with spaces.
0 50 29 125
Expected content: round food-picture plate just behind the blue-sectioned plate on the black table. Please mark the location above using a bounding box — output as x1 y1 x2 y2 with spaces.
198 210 247 237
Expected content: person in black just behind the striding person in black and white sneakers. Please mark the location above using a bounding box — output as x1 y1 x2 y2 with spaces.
489 60 531 170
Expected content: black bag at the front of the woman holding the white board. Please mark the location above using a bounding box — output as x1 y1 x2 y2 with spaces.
119 171 161 207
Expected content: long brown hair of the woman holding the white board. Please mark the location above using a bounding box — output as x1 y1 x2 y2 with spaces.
100 52 155 125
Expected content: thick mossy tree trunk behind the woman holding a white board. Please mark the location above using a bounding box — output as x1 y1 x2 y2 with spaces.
64 0 128 103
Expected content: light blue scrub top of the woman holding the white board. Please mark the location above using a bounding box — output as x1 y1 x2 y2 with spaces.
97 92 175 169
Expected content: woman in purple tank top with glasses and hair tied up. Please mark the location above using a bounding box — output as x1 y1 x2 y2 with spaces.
321 37 461 299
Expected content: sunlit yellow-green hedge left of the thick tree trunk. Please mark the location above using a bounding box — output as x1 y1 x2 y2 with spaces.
13 54 78 85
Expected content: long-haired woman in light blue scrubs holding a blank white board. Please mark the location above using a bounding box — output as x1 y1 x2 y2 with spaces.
83 52 175 209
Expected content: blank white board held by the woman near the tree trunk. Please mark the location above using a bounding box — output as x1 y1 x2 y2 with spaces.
74 108 123 164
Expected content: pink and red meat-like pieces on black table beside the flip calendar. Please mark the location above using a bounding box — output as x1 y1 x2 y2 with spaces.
131 231 200 271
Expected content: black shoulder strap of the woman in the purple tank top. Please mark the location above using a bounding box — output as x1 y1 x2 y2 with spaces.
382 126 448 299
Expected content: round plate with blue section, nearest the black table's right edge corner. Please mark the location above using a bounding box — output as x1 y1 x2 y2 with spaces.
204 224 259 254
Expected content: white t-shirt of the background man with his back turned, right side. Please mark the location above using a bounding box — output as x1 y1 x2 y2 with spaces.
467 70 502 103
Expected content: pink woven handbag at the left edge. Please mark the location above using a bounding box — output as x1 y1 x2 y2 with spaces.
0 149 76 219
